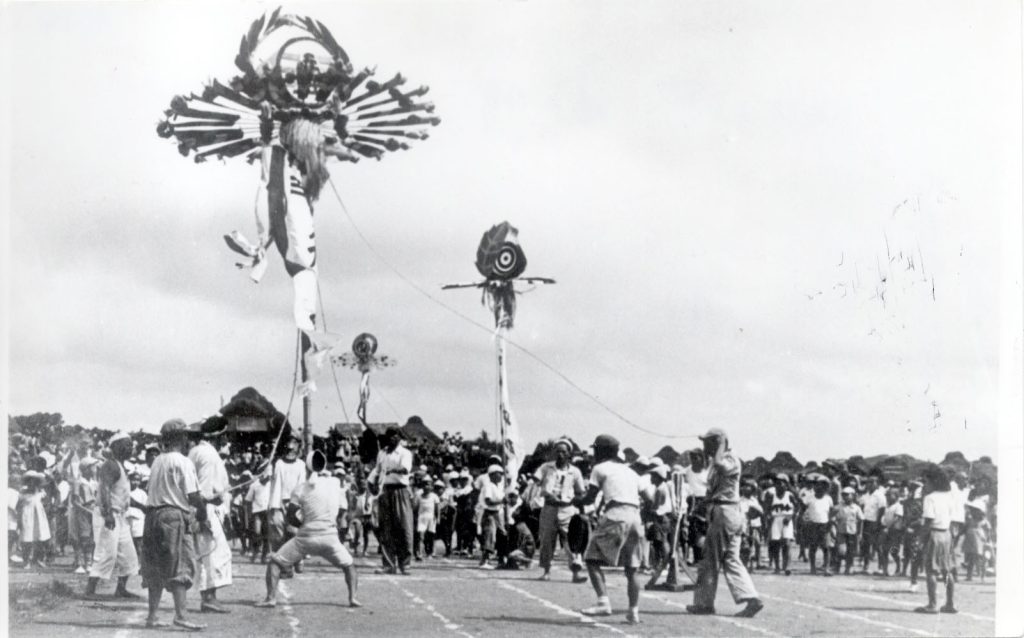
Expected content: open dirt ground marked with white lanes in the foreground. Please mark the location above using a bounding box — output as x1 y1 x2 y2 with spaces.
9 544 995 638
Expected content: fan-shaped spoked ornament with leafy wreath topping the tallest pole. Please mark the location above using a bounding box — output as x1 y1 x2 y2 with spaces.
157 7 440 162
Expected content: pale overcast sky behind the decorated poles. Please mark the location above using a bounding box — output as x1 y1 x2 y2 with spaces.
7 1 1021 461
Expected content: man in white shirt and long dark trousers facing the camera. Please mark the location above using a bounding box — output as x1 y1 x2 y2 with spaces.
368 426 413 575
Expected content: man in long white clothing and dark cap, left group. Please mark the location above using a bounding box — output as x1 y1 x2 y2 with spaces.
188 421 231 613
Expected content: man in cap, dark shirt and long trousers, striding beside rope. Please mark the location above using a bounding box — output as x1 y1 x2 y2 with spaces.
686 428 764 618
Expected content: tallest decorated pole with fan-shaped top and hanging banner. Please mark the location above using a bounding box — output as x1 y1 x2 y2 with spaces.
157 8 440 450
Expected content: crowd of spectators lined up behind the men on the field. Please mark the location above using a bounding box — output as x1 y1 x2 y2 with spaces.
7 411 997 598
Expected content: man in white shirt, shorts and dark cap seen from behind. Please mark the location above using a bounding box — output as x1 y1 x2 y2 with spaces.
572 434 643 625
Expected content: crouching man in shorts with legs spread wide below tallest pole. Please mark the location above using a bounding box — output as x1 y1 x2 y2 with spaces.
256 450 361 607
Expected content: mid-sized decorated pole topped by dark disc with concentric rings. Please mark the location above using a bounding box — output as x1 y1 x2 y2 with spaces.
441 221 555 481
